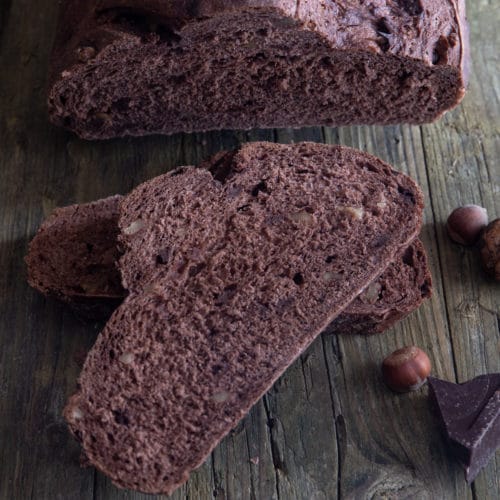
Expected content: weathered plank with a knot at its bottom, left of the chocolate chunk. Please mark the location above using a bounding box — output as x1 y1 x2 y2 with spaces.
324 122 470 498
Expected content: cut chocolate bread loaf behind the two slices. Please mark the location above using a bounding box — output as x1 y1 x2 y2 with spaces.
48 0 468 139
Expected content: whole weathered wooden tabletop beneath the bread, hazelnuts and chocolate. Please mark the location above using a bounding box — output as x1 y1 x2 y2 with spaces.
0 0 500 500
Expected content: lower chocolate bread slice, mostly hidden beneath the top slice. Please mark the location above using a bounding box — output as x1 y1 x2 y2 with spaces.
26 196 431 334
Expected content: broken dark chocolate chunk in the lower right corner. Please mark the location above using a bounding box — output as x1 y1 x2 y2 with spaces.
429 373 500 483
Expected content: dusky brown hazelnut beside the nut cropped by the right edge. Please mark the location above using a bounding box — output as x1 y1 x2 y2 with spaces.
446 205 488 246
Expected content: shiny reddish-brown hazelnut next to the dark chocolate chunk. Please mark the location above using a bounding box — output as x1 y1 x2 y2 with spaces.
382 346 431 392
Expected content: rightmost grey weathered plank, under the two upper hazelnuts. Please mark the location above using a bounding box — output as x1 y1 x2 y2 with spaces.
416 1 500 498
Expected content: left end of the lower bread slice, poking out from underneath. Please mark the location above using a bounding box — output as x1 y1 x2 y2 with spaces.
25 195 125 318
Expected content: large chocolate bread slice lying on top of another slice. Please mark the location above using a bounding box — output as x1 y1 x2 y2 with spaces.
64 143 423 493
